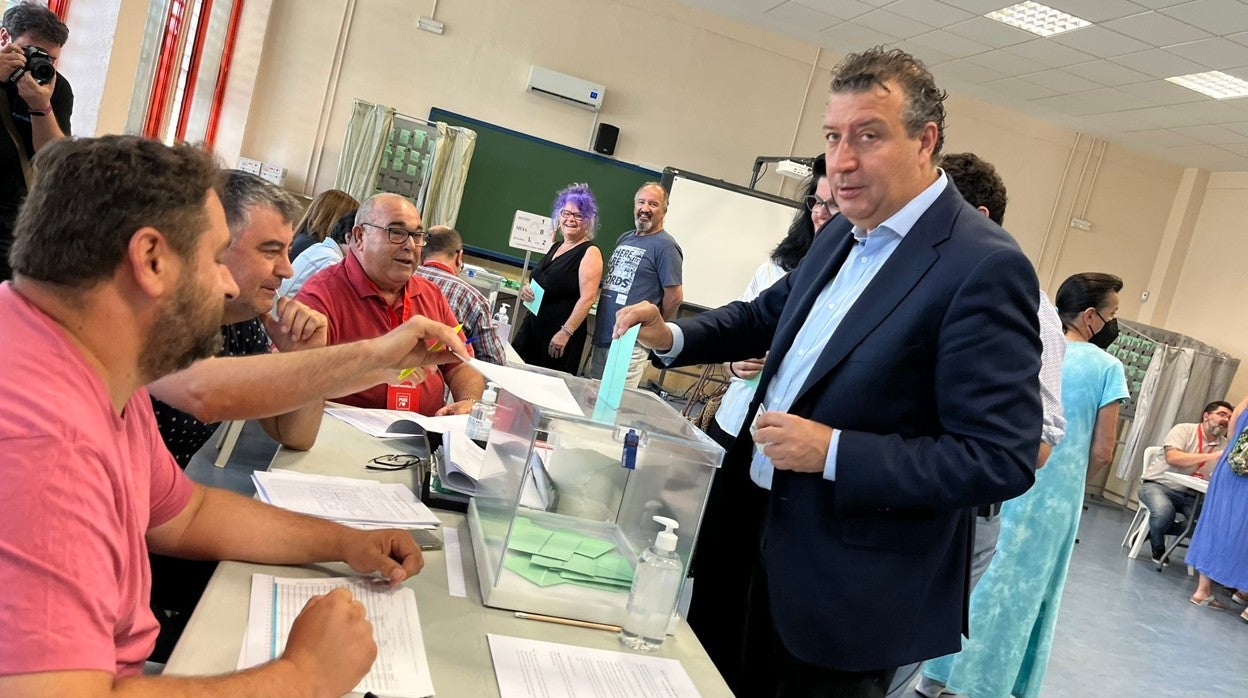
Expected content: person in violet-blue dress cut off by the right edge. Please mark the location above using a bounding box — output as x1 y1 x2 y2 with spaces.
1187 398 1248 623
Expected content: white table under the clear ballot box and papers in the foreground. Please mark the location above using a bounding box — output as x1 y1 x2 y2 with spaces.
165 416 731 698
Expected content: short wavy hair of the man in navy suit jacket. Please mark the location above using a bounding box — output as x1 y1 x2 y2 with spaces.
830 46 946 161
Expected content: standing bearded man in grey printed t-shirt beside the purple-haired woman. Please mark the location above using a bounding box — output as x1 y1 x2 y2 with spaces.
589 182 685 388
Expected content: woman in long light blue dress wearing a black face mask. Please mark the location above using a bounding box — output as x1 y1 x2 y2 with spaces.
919 273 1128 698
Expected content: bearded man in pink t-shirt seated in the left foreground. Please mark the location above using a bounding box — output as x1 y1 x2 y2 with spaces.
0 136 466 697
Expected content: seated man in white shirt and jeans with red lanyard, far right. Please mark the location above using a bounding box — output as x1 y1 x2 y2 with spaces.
1139 400 1234 562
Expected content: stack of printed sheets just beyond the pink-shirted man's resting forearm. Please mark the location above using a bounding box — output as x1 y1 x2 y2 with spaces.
251 471 442 528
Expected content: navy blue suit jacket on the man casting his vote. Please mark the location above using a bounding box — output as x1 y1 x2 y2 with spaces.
674 185 1041 671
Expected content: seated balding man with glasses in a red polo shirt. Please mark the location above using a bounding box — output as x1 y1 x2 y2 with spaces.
296 194 485 415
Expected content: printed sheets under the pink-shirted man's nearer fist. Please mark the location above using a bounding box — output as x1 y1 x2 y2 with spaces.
238 574 433 698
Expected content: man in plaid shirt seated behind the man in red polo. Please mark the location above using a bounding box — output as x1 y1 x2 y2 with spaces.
416 226 507 365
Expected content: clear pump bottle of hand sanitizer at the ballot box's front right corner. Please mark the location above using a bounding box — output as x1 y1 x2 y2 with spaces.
620 516 685 652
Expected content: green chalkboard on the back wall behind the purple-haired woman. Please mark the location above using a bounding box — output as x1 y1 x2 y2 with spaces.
429 107 661 266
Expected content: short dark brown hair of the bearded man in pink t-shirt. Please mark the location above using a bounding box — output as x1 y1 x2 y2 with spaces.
9 136 220 290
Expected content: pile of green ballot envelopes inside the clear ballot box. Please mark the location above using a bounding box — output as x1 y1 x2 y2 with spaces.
503 517 633 592
